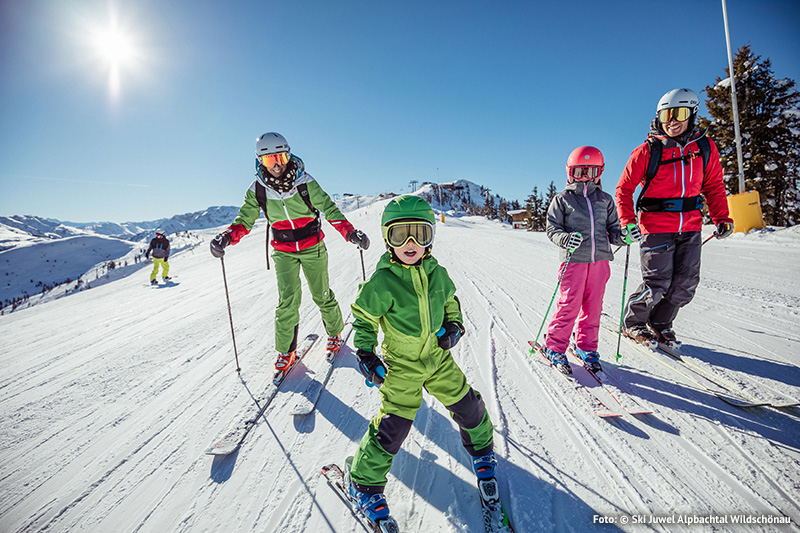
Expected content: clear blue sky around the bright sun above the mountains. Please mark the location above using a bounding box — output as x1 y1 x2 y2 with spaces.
0 0 800 222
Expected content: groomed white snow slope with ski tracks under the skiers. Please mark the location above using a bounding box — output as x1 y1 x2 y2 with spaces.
0 201 800 533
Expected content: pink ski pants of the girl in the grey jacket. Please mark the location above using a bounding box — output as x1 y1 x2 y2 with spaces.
545 261 611 353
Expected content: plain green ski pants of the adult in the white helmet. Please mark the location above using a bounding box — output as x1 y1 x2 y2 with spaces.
272 243 344 353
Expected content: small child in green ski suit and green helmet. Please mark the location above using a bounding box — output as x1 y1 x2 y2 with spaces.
348 195 497 522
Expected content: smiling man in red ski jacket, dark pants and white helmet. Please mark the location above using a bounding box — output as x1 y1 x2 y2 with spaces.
616 89 733 347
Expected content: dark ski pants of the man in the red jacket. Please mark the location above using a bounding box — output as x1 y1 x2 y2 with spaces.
624 231 703 331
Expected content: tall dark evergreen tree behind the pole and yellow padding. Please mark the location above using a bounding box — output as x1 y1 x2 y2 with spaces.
698 45 800 226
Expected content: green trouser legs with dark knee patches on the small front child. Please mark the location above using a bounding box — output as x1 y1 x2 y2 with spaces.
350 352 494 493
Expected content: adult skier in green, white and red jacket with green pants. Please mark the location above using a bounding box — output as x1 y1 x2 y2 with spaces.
206 132 369 382
